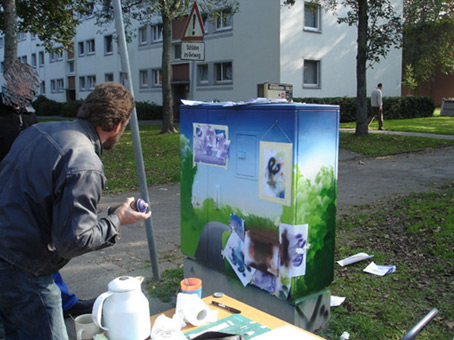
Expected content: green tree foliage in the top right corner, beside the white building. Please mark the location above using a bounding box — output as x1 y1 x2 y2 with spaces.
403 0 454 84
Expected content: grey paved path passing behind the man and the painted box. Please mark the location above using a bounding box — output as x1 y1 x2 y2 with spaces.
56 131 454 339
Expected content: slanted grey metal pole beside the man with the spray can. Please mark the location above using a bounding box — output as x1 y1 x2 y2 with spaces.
113 0 161 280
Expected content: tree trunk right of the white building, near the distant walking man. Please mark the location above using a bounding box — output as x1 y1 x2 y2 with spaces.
356 0 369 136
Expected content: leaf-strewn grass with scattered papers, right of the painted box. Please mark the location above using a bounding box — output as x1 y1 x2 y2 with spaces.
321 182 454 340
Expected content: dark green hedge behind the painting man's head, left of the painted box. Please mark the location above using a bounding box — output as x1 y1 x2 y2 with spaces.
32 96 162 120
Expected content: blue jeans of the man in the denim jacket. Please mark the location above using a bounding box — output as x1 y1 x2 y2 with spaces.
0 259 68 340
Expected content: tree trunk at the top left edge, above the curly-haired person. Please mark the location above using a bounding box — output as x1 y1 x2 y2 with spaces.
2 0 17 72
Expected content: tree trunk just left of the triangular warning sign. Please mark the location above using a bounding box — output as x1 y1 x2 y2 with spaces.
161 9 177 133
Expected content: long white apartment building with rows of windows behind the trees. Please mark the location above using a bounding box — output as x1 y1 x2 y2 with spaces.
0 0 402 104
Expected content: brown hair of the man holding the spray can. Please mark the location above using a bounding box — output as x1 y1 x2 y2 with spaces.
77 81 134 131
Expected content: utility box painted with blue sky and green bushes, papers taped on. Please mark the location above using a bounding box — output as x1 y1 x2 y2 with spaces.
180 103 339 301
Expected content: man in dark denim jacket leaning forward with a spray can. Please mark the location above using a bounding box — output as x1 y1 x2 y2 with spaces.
0 82 151 340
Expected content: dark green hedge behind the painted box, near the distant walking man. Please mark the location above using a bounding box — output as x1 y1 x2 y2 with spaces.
293 96 435 123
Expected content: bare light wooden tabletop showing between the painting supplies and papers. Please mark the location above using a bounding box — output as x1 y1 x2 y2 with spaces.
150 295 324 340
